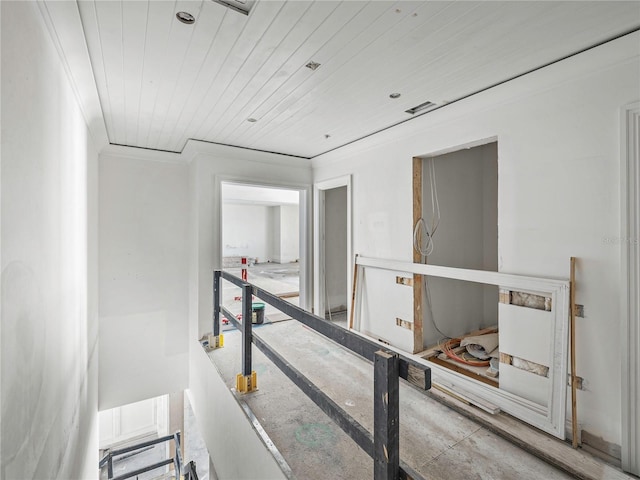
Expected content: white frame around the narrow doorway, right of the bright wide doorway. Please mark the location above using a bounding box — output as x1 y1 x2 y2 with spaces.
313 175 353 318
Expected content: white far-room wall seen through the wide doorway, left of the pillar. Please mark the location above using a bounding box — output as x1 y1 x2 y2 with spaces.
222 203 273 262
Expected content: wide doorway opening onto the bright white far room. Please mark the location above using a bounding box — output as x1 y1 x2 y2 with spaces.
221 182 304 321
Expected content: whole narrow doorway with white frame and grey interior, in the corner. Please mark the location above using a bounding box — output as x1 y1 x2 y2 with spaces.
314 176 353 328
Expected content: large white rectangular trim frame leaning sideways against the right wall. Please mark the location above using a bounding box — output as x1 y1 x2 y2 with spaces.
354 256 569 439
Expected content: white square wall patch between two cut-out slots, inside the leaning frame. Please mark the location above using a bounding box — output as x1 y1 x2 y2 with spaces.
498 303 554 368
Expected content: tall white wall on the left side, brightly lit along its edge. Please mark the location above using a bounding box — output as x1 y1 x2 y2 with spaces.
0 2 98 480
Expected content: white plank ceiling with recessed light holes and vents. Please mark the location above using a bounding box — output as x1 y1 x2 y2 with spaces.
78 0 640 158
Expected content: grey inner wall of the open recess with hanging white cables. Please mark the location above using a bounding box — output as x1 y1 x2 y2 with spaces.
423 143 498 346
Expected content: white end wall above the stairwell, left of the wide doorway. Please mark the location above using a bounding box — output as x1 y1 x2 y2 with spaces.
99 153 189 410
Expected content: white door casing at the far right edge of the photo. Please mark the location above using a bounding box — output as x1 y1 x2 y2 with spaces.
619 102 640 475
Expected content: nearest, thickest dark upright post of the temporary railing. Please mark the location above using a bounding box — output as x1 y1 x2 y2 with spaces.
373 350 400 480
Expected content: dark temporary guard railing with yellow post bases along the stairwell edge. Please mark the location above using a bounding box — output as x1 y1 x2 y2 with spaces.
210 270 431 480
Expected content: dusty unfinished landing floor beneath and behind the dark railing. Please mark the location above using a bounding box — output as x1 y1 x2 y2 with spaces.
209 321 572 480
